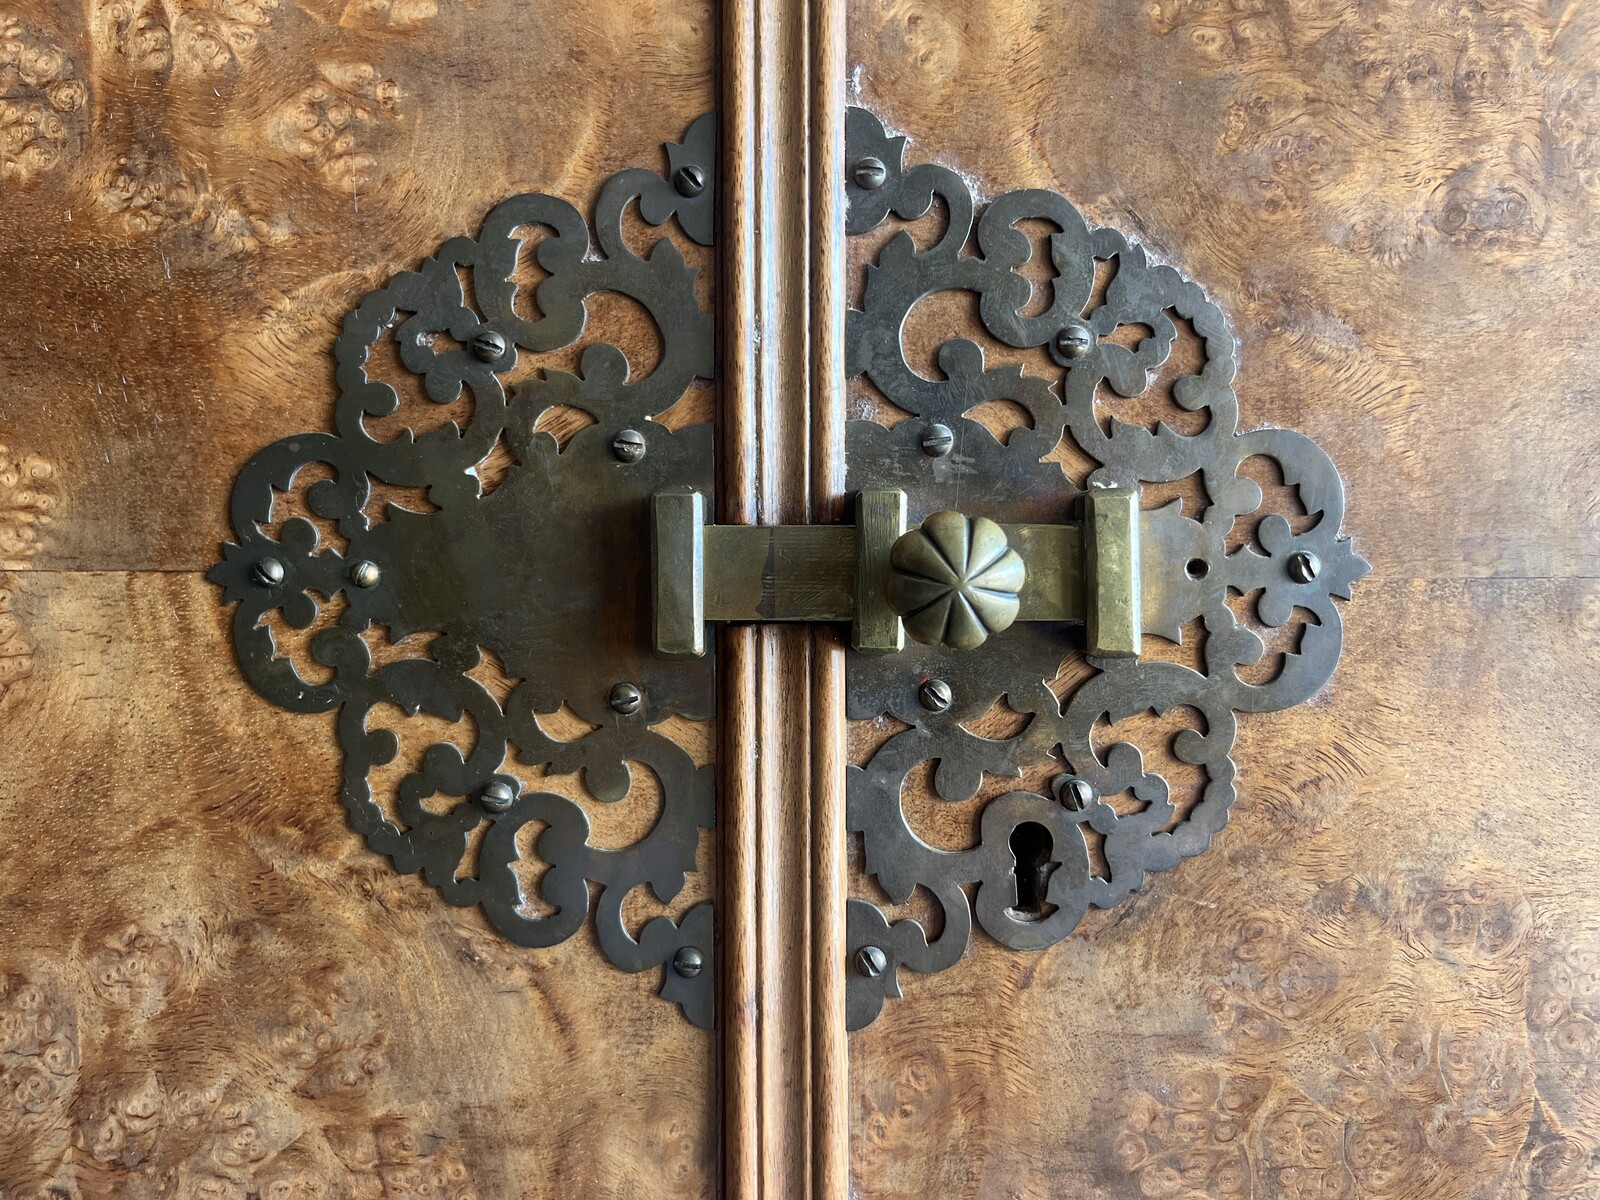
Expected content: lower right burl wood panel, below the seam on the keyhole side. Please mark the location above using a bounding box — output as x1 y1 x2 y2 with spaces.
851 581 1600 1197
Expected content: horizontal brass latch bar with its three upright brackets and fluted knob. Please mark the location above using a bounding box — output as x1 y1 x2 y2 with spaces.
653 488 1149 658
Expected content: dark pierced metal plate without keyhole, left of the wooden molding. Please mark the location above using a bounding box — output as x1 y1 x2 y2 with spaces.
208 117 715 1026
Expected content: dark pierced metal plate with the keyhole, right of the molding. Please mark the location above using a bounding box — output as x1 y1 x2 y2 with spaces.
846 109 1368 1029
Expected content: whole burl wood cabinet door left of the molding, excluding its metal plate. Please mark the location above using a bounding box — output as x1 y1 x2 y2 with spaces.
0 0 717 1200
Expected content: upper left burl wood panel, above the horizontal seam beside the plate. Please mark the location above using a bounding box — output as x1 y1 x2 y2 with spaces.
0 0 717 570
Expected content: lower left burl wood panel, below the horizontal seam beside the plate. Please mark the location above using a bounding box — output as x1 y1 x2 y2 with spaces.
0 571 715 1197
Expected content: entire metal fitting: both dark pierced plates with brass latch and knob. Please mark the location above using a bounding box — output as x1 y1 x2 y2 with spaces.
210 109 1368 1027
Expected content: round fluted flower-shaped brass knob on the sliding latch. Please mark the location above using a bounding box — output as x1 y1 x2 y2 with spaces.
885 512 1027 650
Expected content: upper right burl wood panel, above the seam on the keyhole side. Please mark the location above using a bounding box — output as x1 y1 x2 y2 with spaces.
850 0 1600 578
